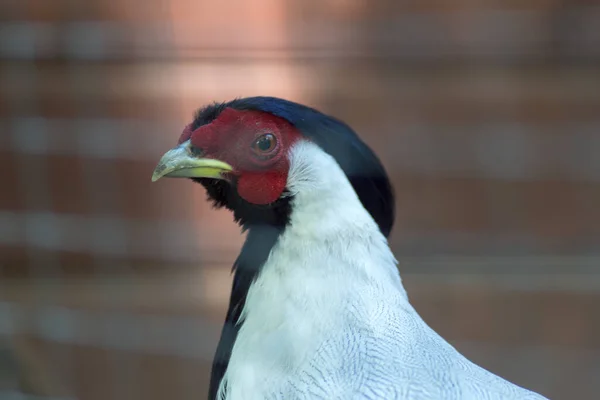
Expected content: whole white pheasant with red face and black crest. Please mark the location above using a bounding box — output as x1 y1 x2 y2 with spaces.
152 96 545 400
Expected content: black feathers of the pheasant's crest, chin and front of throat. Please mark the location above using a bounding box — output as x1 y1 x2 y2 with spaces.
192 97 395 400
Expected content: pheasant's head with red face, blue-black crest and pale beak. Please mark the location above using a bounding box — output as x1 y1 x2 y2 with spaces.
152 97 394 236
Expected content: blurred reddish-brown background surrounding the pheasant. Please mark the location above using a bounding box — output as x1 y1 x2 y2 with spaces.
0 0 600 400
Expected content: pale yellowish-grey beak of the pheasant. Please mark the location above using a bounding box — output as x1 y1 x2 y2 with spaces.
152 142 233 182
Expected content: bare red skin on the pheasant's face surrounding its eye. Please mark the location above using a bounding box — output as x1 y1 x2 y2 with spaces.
179 108 302 204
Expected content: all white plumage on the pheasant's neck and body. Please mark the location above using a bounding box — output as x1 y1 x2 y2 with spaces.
219 141 544 400
